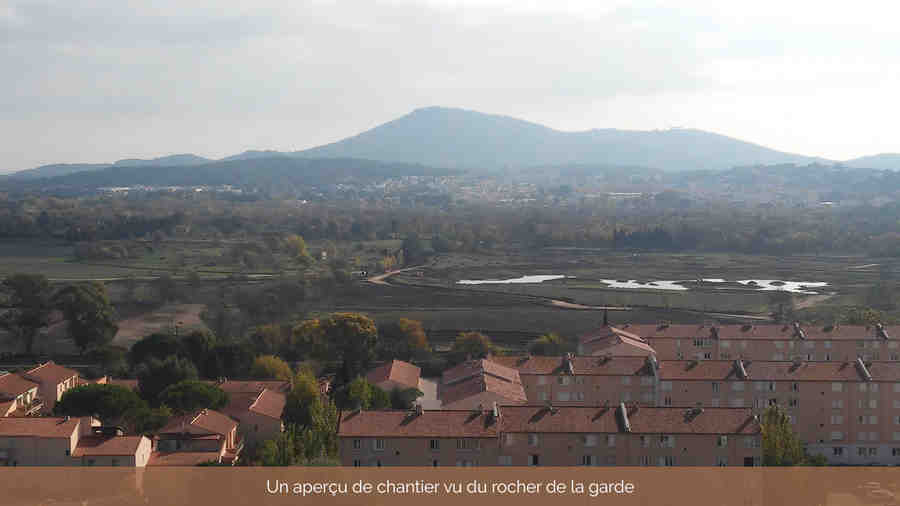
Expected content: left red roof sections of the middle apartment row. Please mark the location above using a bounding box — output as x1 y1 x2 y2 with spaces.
491 355 650 376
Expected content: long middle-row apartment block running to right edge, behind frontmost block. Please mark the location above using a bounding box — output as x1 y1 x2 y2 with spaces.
492 356 900 464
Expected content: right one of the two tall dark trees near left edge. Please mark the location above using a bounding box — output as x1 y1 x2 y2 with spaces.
53 281 119 353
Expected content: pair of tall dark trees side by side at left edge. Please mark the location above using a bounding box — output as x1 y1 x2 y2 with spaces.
0 274 118 354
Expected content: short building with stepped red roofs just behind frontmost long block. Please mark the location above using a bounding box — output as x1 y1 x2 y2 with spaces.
438 359 527 410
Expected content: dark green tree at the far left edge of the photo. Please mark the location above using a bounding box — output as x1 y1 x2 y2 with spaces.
0 274 53 355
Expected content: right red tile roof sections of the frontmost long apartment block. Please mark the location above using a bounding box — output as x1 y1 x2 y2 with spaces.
500 406 759 435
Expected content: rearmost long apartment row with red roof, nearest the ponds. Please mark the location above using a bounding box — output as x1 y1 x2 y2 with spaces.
624 323 900 362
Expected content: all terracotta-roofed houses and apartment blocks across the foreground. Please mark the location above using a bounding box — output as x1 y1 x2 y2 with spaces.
0 321 900 467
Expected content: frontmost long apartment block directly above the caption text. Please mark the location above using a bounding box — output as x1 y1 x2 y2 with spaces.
338 403 761 466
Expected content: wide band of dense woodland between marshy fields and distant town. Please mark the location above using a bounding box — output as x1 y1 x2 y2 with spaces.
0 193 900 258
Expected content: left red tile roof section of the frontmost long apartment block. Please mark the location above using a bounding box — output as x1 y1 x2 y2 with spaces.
338 410 497 438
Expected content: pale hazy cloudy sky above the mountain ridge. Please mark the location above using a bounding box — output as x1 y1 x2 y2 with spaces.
0 0 900 172
